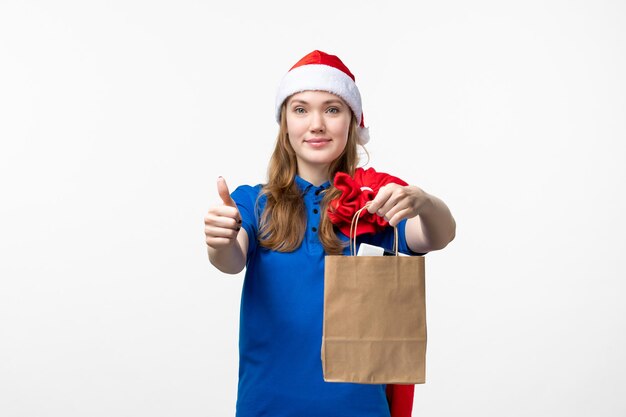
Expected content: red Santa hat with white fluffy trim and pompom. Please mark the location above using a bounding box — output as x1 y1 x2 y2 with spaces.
276 50 369 145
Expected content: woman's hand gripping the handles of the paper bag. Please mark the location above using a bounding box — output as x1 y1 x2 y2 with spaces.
367 183 431 227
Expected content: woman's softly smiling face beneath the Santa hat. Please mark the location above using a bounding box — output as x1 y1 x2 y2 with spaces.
285 91 352 175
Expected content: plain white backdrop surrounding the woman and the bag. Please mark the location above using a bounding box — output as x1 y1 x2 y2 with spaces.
0 0 626 417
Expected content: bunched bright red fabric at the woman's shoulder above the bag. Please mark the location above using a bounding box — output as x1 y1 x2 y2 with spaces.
328 168 409 236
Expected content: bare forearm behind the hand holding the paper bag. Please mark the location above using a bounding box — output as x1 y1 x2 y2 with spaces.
406 194 456 253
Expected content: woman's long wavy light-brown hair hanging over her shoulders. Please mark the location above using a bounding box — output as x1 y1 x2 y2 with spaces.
259 103 367 255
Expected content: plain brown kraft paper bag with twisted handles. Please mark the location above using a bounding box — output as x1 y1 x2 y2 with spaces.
321 207 426 384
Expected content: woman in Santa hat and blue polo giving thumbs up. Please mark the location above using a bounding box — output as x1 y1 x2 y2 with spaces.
205 51 455 417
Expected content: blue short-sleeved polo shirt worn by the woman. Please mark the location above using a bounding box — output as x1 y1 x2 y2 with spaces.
231 176 414 417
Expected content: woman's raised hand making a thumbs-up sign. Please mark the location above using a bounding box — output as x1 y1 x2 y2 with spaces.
204 177 241 249
